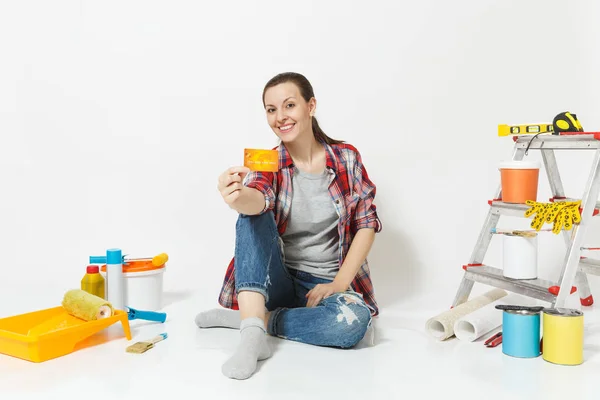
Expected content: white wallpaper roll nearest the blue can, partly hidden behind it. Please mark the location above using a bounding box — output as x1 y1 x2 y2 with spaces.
454 293 529 342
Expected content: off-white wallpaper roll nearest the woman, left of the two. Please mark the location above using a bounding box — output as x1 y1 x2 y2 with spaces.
425 288 508 340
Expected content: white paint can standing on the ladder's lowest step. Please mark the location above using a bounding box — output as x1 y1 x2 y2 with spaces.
502 234 538 279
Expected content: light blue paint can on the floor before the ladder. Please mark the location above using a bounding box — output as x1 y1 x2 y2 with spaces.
502 310 540 358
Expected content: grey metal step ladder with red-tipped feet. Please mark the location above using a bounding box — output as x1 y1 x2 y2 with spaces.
452 132 600 308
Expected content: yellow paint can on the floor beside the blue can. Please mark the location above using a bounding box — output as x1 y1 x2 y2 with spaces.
542 308 583 365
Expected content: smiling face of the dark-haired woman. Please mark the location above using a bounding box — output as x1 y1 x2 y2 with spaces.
265 82 316 143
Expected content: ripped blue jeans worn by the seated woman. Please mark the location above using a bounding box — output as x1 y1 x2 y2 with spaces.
234 212 371 348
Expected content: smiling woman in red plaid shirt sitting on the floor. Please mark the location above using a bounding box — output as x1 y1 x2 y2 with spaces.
196 72 381 379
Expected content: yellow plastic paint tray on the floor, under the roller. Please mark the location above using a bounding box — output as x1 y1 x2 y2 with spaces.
0 306 131 363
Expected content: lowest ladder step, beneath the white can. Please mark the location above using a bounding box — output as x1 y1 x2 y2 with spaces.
465 265 556 302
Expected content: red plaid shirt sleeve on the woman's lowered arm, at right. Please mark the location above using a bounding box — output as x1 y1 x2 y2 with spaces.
351 151 382 233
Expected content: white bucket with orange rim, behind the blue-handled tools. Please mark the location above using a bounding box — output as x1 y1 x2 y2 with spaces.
100 260 166 311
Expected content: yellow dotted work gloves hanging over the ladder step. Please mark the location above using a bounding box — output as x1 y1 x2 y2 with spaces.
525 200 581 234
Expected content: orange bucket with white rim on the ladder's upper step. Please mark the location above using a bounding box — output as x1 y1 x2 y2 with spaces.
499 161 541 204
